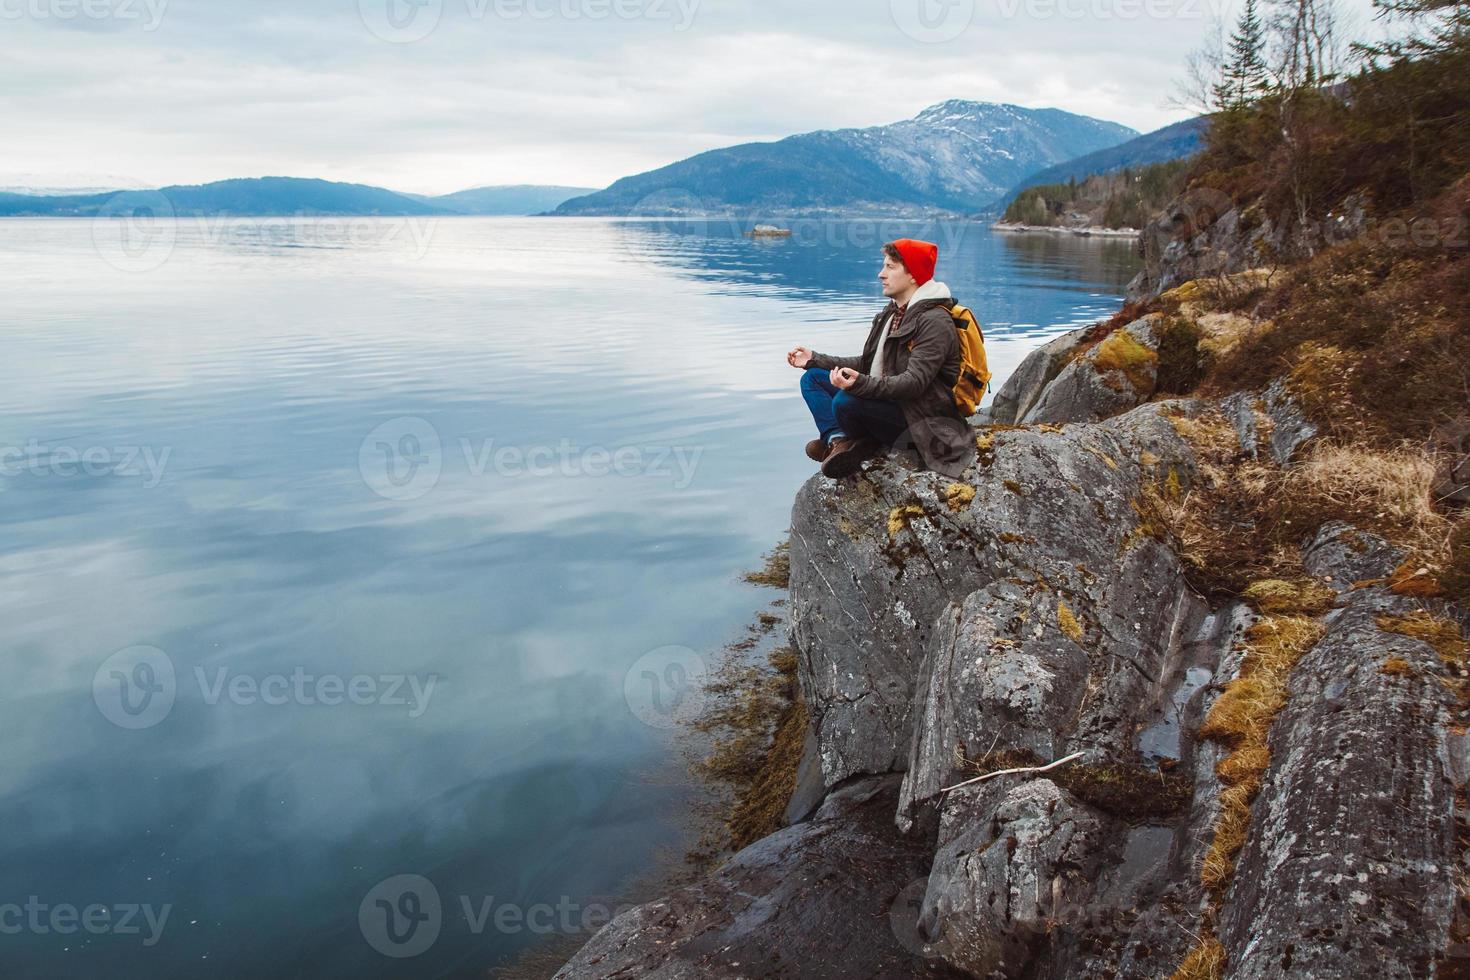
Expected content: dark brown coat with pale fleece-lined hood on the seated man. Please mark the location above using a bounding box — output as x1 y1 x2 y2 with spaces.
807 282 975 479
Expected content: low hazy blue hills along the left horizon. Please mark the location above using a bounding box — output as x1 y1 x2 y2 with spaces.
0 176 587 217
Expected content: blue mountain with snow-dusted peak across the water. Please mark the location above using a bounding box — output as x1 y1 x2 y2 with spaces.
556 100 1138 215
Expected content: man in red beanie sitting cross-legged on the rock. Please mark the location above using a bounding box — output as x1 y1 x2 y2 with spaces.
786 238 975 479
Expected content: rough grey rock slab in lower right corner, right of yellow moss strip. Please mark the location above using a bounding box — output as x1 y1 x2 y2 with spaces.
1220 578 1464 980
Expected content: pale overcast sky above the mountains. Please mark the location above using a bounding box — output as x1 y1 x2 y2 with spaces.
0 0 1370 192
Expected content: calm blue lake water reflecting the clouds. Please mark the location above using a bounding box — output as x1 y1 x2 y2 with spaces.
0 219 1136 980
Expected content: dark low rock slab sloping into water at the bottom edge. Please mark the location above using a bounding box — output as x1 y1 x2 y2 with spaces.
556 777 964 980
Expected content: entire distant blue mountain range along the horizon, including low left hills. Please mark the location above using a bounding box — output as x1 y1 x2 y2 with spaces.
0 107 1205 217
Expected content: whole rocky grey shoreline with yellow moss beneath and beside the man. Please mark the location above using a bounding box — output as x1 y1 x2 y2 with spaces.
557 195 1470 980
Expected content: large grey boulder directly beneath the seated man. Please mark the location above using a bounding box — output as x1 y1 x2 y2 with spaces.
791 403 1192 801
